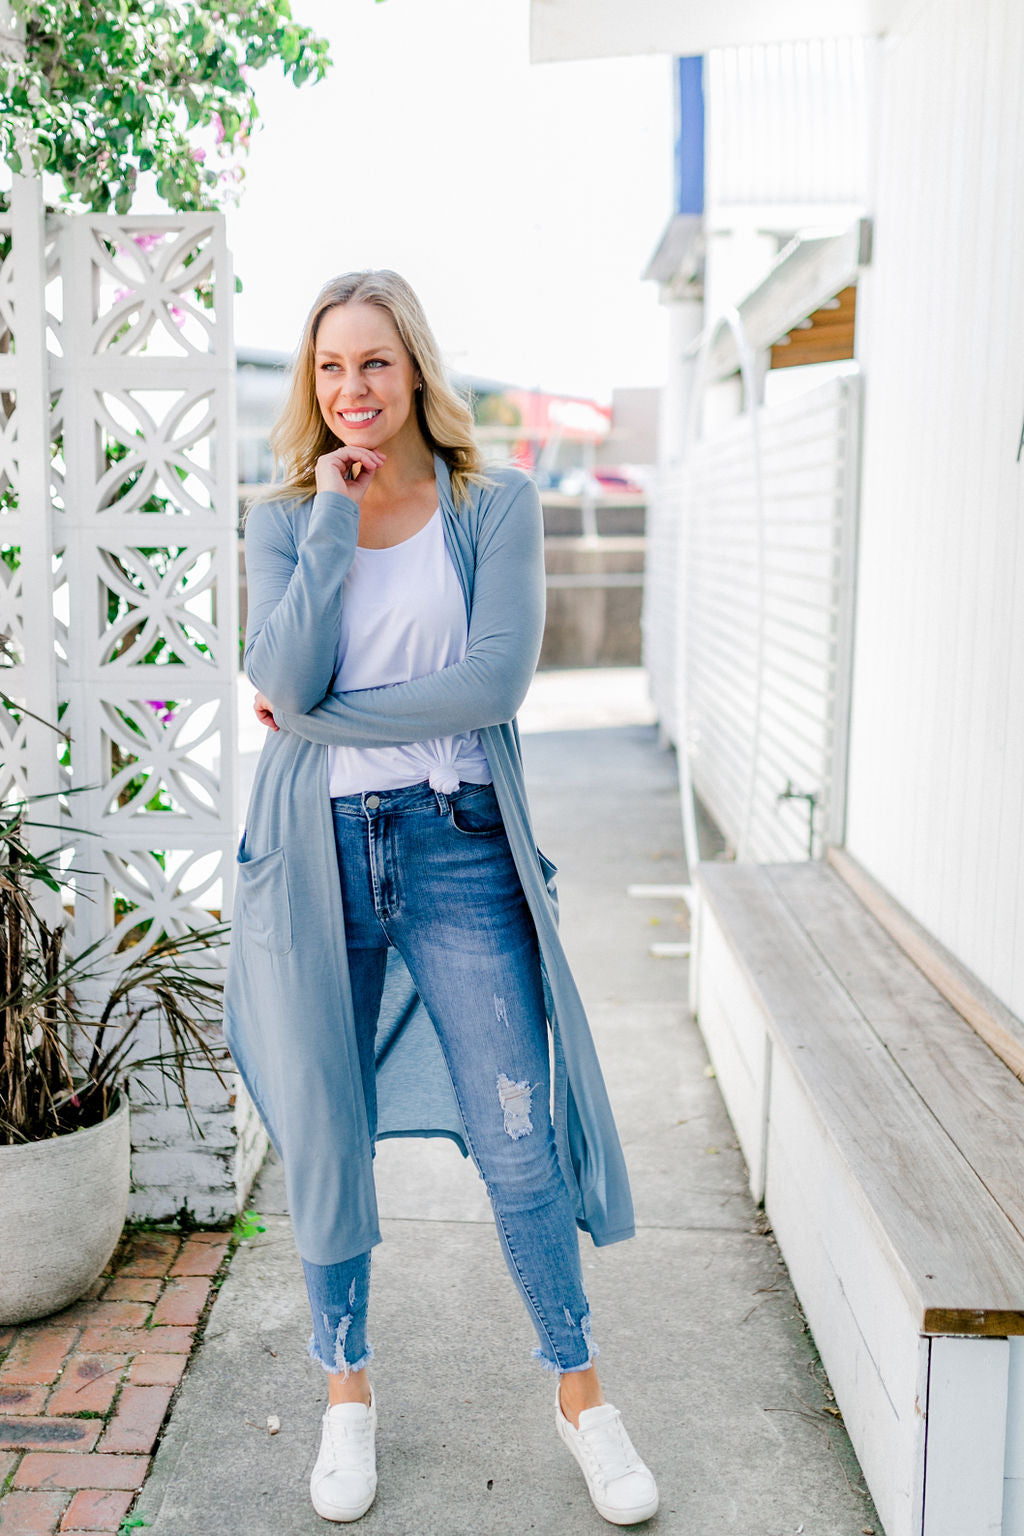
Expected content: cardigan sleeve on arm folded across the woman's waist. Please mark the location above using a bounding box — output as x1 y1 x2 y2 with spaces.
271 481 545 746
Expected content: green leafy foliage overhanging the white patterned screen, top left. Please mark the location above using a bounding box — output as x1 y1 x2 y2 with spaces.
0 0 332 214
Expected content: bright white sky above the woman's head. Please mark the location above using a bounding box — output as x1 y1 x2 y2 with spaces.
222 0 672 399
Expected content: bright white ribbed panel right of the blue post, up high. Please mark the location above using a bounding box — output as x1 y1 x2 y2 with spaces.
705 38 878 209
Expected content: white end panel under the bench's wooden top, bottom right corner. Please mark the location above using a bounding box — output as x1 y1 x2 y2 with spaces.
923 1338 1018 1536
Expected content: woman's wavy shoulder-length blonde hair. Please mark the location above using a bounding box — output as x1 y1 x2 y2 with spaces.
255 269 488 507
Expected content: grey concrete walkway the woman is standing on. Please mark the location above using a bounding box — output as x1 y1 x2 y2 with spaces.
137 671 881 1536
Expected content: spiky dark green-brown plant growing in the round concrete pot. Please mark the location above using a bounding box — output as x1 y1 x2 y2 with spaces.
0 802 229 1143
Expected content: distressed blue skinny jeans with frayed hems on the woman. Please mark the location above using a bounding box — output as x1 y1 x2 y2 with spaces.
302 783 597 1375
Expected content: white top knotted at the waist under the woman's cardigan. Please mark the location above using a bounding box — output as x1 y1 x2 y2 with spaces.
329 508 491 797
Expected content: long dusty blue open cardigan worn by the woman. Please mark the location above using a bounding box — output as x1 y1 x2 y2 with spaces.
224 456 634 1264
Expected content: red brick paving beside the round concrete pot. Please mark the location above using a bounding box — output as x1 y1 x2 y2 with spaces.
0 1230 230 1536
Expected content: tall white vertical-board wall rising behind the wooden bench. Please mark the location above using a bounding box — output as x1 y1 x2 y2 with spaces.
846 0 1024 1017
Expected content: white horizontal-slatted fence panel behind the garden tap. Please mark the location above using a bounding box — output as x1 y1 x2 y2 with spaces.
682 365 860 860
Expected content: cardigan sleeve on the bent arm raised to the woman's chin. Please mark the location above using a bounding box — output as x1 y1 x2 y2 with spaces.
244 492 359 714
